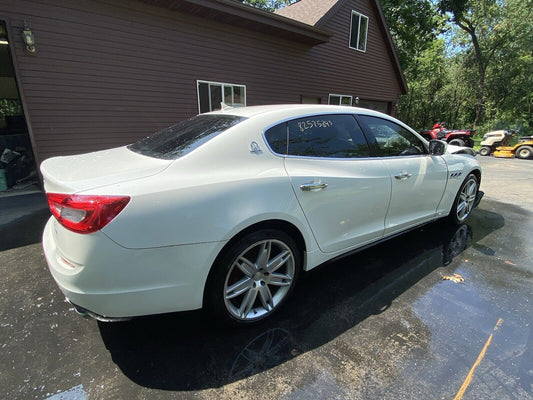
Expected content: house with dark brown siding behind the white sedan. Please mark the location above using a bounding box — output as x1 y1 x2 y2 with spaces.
0 0 407 189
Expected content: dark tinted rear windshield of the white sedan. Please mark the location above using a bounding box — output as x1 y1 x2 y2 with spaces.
128 115 246 160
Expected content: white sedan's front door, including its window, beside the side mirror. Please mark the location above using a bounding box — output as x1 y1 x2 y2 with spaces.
357 115 448 235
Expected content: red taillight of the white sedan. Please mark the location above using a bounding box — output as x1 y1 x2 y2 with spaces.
46 193 130 233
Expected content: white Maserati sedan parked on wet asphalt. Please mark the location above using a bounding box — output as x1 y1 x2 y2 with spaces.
41 105 482 324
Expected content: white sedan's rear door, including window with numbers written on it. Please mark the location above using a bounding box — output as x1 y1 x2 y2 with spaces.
266 114 391 252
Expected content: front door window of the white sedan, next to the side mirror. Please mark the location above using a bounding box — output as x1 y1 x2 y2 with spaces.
358 115 427 157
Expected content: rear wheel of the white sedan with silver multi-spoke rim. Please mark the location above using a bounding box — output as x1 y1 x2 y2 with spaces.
204 229 301 326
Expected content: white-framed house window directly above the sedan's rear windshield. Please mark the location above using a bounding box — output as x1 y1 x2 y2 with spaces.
197 81 246 113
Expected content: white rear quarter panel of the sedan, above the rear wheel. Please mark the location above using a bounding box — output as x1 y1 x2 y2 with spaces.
93 117 316 249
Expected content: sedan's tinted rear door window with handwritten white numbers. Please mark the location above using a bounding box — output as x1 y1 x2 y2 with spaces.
287 114 370 158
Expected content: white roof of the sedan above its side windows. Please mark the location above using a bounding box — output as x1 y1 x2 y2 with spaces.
207 104 390 118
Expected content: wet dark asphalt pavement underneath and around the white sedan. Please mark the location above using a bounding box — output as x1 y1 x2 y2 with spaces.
0 195 533 400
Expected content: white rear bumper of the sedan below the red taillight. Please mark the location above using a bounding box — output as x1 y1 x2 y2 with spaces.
43 218 224 319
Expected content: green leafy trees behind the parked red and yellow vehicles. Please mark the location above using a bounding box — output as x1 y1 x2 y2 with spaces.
387 0 533 134
